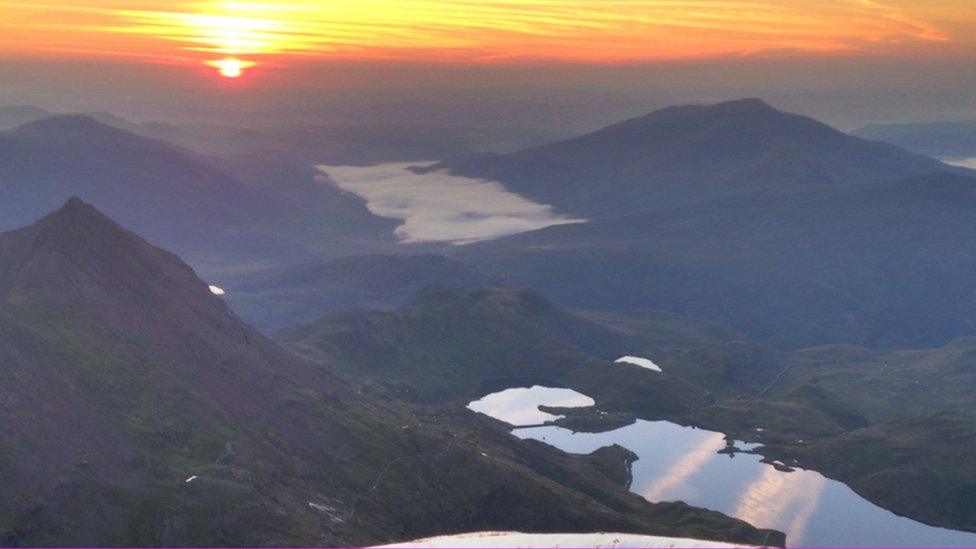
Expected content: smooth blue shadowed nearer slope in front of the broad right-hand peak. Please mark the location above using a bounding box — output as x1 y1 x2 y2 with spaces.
458 173 976 348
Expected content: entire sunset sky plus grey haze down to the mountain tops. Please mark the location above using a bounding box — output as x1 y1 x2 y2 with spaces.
0 0 976 133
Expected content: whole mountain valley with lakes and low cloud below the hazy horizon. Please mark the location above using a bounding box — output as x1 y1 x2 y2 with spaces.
0 99 976 547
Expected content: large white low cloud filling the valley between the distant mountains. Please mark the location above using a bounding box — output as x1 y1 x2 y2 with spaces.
319 163 585 244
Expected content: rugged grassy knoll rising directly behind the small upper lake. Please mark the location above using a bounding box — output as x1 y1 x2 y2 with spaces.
277 286 706 415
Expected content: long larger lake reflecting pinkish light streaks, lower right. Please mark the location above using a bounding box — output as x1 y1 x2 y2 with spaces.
476 393 976 547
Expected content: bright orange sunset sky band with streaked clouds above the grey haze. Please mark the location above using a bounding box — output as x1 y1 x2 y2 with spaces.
0 0 976 77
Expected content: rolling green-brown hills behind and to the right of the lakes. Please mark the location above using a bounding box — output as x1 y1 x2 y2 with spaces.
279 288 976 529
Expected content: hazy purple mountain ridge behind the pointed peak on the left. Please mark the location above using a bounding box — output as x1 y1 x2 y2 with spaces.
0 115 395 270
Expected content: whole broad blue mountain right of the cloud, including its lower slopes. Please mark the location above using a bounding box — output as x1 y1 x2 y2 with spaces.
428 100 976 347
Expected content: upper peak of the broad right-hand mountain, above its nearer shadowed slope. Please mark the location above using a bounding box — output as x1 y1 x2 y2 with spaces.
430 99 952 218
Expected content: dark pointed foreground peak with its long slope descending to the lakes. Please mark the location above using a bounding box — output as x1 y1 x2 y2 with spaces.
0 199 781 546
